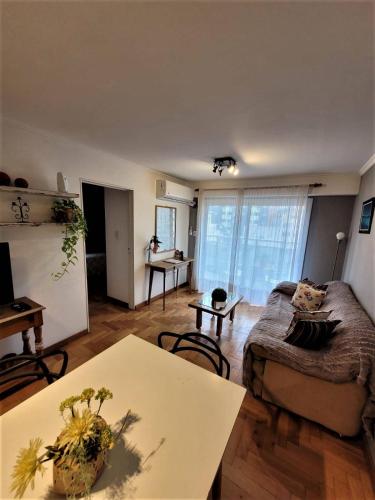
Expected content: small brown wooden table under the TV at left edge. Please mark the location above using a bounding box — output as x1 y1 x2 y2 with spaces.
0 297 45 354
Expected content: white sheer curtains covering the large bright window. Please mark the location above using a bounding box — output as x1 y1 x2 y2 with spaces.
197 186 311 305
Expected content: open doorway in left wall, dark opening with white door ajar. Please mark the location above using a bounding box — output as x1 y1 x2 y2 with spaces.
82 181 134 316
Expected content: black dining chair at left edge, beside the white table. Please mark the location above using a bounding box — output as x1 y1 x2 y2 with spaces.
0 349 68 400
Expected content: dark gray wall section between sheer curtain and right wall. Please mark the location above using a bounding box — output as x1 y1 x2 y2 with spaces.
302 196 355 283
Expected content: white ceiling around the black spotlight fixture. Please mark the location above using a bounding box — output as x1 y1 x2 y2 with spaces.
2 1 374 180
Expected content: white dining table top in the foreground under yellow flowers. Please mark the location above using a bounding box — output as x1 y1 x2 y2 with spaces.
0 335 245 499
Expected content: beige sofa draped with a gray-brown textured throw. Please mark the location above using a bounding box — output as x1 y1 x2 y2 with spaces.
243 283 375 436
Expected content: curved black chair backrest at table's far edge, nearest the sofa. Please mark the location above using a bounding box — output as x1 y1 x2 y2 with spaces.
158 332 230 380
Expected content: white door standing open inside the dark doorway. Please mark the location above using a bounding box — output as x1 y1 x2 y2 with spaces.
104 188 133 305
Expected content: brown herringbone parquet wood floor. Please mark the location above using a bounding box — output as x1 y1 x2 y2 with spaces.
1 290 375 500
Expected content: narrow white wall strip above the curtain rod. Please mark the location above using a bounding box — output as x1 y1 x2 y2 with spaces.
194 172 360 196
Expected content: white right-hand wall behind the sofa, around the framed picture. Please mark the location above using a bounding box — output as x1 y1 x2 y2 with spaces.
343 165 375 322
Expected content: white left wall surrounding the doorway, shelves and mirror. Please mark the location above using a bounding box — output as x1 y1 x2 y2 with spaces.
0 120 189 355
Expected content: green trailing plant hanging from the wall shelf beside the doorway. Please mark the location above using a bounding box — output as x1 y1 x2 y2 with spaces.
51 199 87 281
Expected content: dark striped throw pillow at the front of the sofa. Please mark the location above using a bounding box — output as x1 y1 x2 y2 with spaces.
284 319 341 350
